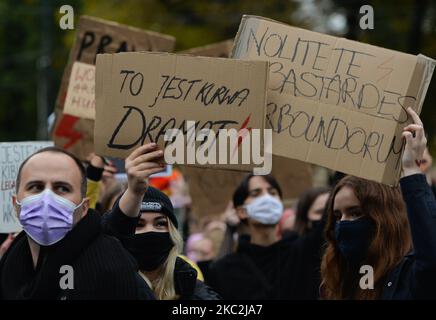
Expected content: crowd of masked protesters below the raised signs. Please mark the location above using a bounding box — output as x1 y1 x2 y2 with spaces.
0 110 436 300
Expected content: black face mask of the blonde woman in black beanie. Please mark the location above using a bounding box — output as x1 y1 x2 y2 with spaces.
123 232 174 271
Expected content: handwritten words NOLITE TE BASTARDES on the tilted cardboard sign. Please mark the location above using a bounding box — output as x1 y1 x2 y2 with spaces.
245 27 416 124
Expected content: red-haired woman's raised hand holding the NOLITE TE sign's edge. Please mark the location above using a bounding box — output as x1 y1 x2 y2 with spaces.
402 108 427 176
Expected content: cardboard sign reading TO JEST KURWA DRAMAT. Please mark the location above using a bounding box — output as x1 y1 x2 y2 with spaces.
94 52 268 170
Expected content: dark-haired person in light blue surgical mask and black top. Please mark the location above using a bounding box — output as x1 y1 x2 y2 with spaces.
205 174 323 300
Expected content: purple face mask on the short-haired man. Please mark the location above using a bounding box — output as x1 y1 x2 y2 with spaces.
17 189 84 246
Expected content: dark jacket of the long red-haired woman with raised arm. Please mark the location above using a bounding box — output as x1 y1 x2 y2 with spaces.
382 174 436 300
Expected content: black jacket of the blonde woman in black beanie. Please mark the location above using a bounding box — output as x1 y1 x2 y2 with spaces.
103 201 220 300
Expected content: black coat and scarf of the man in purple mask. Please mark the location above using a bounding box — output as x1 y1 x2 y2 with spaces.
0 211 154 300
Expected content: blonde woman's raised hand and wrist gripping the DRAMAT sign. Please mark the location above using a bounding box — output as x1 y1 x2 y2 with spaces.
119 143 165 217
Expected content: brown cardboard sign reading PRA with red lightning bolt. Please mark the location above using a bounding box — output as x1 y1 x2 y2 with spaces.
53 16 175 160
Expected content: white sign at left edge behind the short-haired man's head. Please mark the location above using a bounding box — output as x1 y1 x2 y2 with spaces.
0 141 53 233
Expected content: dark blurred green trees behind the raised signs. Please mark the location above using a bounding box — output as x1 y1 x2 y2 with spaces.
0 0 436 153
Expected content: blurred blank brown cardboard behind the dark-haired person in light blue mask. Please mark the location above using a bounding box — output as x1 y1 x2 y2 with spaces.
180 156 312 217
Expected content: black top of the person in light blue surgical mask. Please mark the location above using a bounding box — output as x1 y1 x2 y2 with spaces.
206 220 325 300
